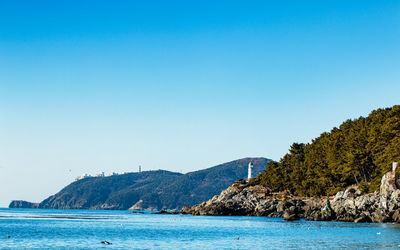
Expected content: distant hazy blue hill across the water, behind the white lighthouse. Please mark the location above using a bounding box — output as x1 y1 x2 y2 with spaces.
32 158 269 210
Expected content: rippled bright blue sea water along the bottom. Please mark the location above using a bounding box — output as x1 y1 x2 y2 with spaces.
0 208 400 249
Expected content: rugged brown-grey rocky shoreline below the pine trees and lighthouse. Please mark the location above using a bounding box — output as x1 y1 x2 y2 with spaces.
181 169 400 223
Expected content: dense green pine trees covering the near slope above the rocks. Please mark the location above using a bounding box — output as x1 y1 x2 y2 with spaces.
257 105 400 196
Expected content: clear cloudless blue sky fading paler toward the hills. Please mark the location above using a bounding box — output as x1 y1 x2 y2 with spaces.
0 0 400 207
